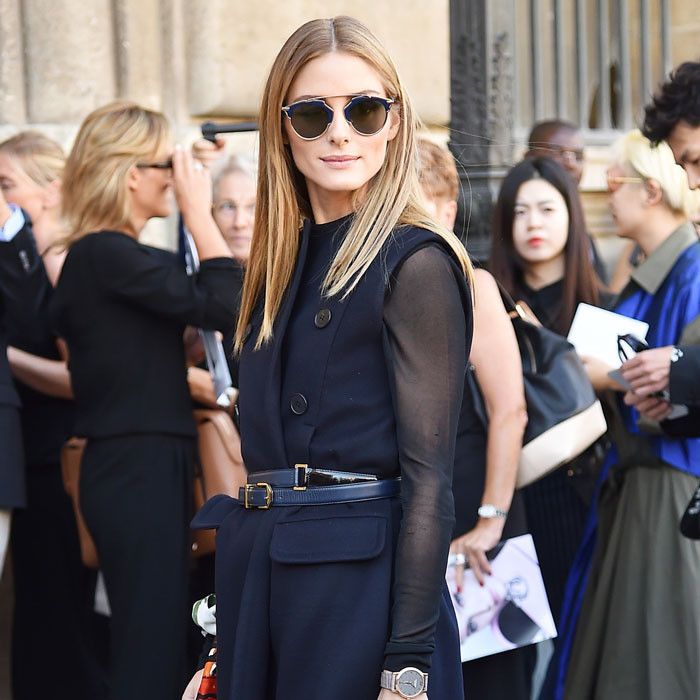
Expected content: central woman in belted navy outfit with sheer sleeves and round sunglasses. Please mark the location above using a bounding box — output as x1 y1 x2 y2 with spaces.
185 17 471 700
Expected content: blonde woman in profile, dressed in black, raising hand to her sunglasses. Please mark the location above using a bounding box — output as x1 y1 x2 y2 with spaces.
51 102 236 700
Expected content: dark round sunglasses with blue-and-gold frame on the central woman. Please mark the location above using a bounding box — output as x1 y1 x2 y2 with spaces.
282 95 394 141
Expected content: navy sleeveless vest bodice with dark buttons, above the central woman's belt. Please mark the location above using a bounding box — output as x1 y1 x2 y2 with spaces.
239 222 462 478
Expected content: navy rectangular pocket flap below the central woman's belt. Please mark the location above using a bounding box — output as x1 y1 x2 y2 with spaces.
270 516 386 564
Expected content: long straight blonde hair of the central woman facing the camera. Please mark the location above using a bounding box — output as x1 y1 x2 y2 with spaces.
235 16 471 350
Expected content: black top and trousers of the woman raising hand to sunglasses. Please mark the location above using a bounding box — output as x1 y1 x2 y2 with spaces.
51 231 236 700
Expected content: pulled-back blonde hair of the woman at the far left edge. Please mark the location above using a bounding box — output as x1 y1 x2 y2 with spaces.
0 131 66 187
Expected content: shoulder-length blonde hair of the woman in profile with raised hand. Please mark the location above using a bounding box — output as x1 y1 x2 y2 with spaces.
61 102 170 247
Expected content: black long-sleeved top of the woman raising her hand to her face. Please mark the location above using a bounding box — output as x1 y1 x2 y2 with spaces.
50 231 238 438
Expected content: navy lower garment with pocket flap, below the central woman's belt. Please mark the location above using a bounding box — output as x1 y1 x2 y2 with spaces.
194 497 463 700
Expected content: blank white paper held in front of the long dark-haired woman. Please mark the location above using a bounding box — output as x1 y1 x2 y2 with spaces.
568 304 649 369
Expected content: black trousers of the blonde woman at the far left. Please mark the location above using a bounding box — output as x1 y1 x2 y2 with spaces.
10 464 107 700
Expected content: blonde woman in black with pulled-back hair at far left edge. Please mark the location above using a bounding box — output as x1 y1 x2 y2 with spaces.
0 131 106 700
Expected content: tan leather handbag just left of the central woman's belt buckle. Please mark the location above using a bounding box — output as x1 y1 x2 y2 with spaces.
192 408 247 557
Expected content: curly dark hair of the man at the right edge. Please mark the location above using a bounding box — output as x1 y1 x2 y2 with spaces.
642 61 700 145
